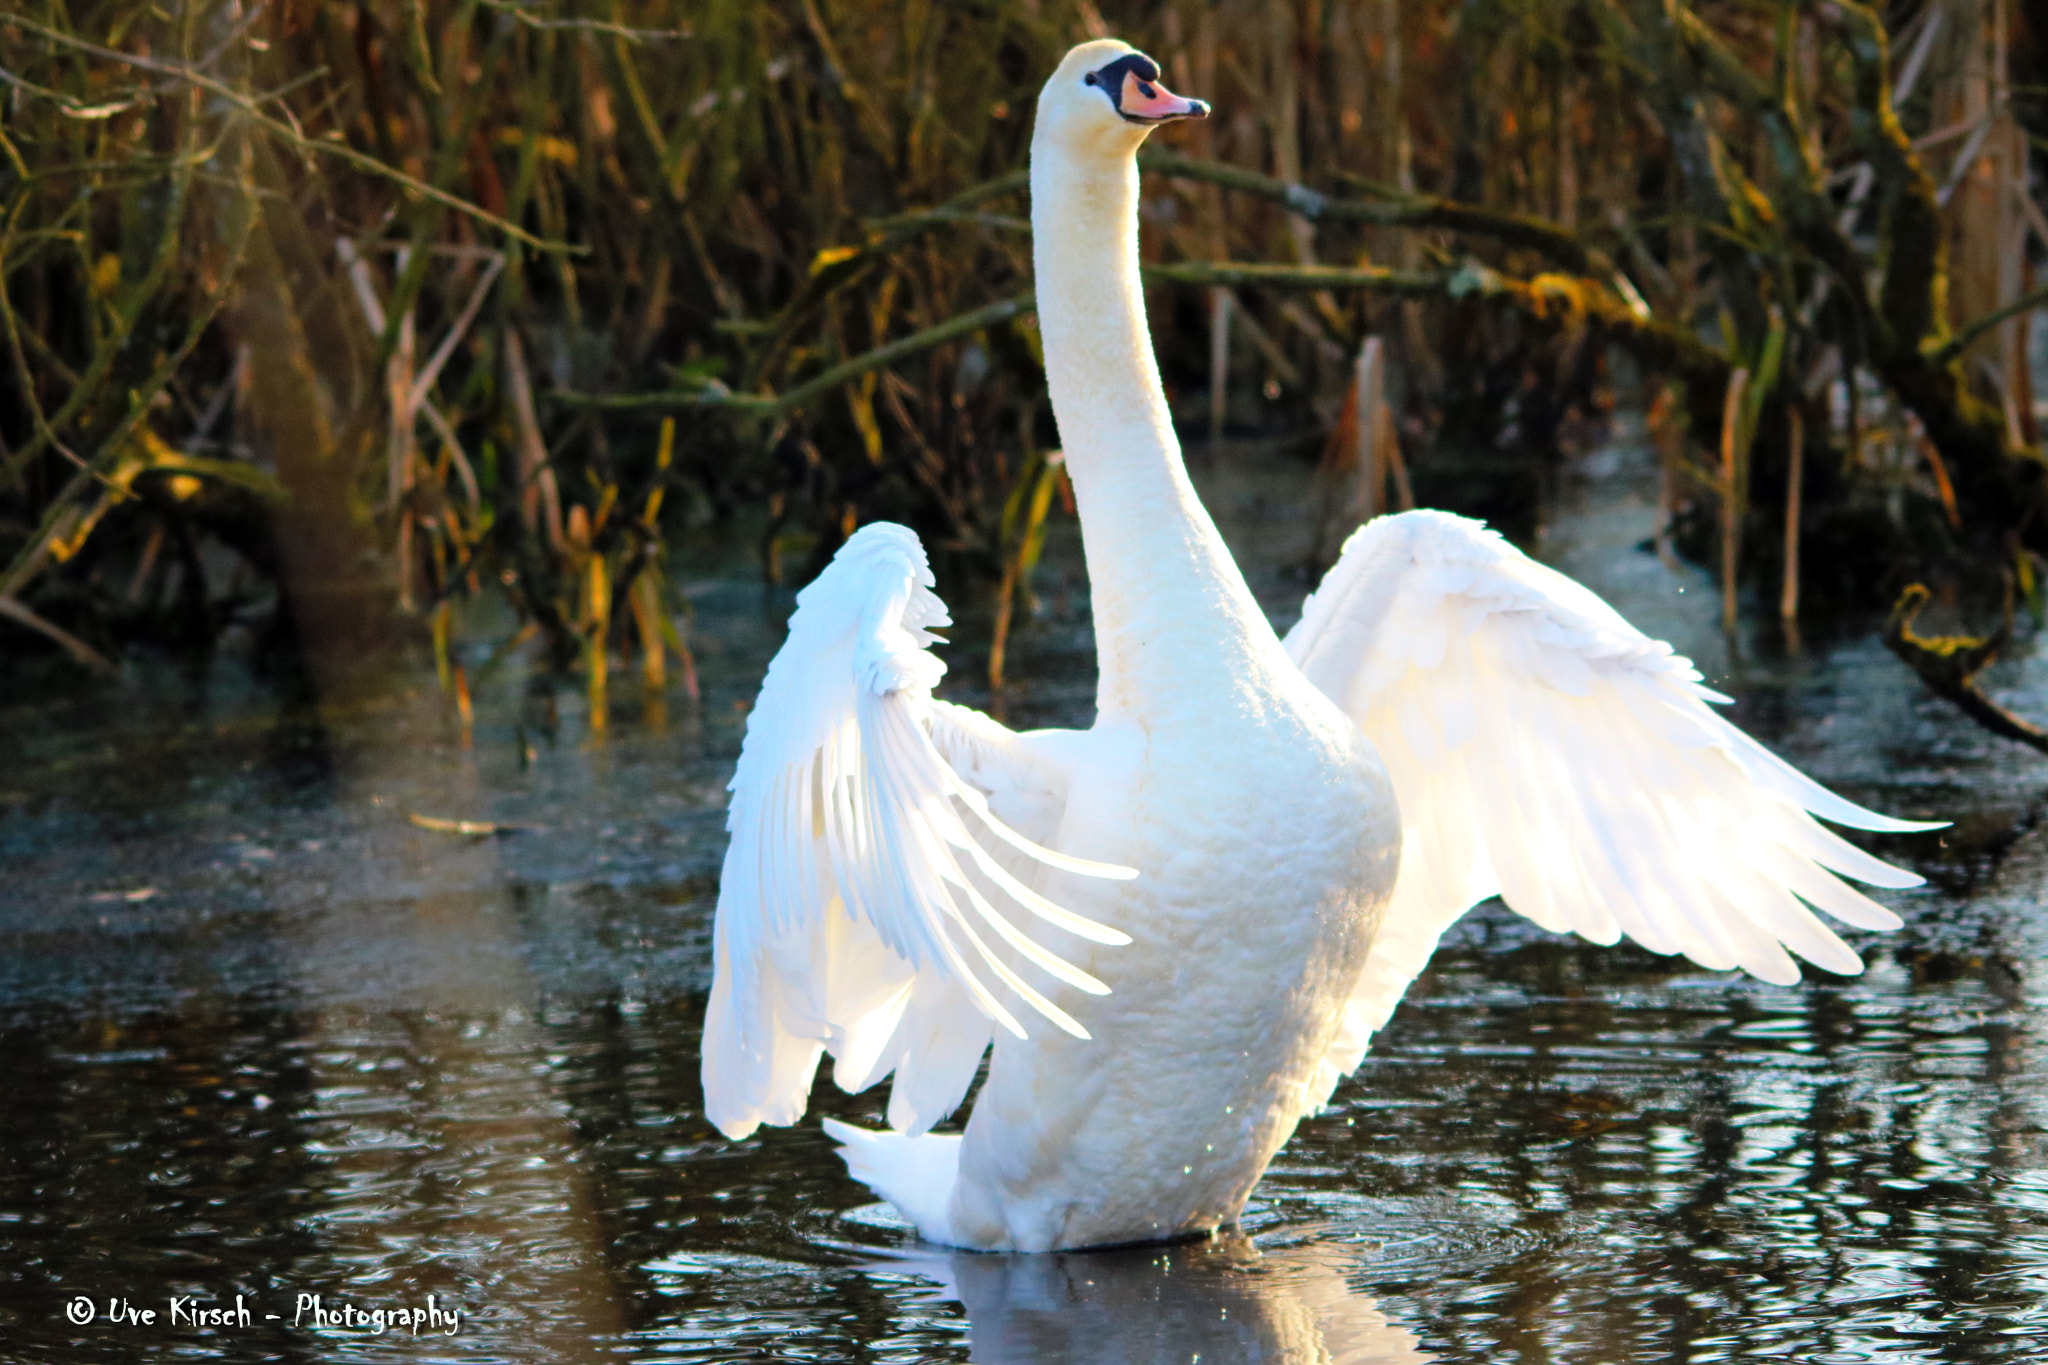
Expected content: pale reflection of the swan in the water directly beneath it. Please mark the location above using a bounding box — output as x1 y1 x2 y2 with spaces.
870 1232 1434 1365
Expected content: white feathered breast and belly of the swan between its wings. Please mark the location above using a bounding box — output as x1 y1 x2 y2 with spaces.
954 698 1399 1248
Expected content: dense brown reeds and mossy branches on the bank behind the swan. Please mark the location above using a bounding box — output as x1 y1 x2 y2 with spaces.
0 0 2048 724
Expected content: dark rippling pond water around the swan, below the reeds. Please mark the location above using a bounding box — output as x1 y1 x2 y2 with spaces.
0 431 2048 1365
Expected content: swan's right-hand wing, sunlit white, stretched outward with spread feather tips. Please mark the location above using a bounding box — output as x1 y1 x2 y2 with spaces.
1286 512 1937 1099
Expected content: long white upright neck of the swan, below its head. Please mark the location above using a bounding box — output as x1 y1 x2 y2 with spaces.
1030 145 1284 714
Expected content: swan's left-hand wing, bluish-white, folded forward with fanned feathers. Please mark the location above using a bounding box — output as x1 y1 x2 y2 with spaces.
705 522 1137 1138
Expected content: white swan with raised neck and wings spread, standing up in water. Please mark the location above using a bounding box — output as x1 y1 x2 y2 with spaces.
702 39 1933 1250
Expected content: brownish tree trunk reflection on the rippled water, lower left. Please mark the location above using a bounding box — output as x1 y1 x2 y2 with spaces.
285 745 623 1361
